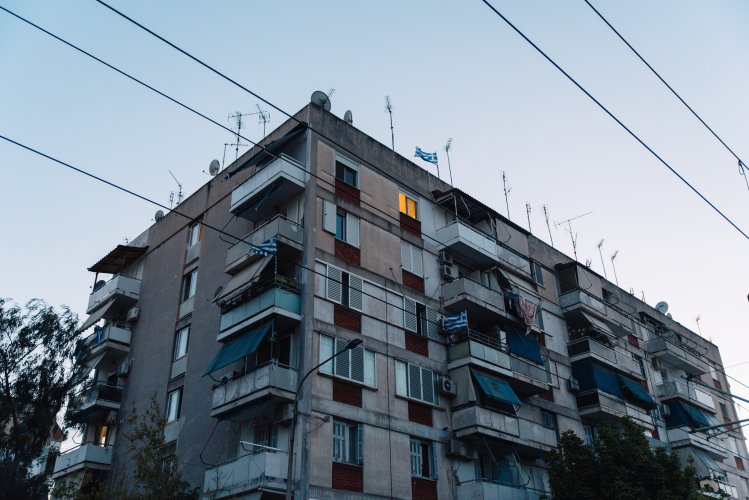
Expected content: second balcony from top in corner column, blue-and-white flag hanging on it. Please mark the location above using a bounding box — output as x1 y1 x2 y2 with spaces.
225 215 304 274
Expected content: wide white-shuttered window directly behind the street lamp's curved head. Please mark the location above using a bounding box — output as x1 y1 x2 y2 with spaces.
319 335 377 387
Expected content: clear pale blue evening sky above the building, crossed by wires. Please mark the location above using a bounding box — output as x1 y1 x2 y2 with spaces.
0 0 749 417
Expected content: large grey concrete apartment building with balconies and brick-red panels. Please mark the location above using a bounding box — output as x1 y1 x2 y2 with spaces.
53 99 749 499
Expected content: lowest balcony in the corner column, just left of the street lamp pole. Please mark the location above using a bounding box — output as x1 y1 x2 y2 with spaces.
203 450 288 498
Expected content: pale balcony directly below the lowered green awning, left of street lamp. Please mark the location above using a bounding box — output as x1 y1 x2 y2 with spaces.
211 363 297 420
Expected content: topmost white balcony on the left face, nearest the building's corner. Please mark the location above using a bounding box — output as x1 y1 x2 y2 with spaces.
229 154 307 221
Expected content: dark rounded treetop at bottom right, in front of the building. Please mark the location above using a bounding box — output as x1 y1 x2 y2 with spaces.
547 418 703 500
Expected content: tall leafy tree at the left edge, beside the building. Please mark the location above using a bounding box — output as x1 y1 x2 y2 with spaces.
0 298 82 499
